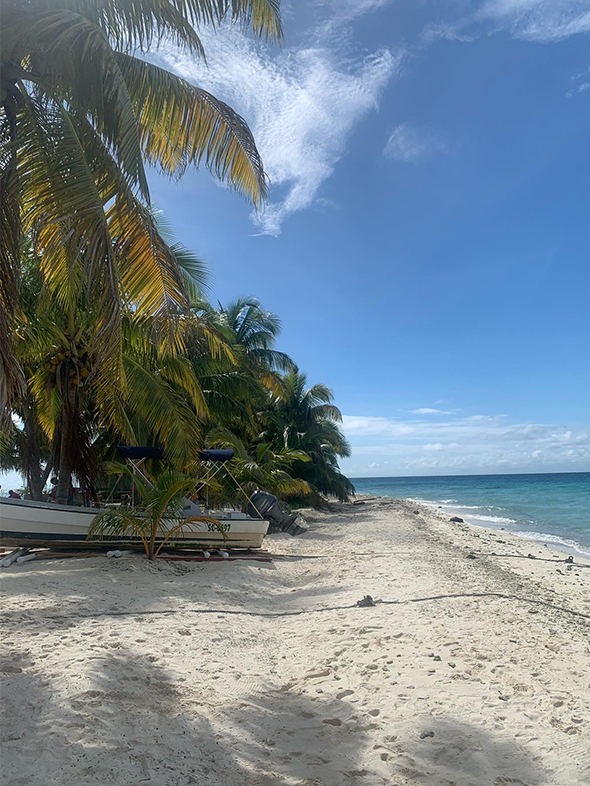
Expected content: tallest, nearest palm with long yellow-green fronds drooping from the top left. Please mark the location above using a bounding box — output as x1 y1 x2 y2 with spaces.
0 0 281 417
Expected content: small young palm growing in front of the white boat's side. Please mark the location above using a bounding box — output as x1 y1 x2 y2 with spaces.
88 464 222 560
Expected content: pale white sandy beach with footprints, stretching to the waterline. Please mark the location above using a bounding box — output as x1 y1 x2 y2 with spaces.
0 500 590 786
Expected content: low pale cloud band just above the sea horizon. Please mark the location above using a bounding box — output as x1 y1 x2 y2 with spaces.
343 415 590 476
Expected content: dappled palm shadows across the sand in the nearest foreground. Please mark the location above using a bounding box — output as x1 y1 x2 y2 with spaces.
2 645 549 786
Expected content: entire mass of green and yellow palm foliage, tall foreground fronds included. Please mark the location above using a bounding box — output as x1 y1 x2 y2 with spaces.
0 0 354 508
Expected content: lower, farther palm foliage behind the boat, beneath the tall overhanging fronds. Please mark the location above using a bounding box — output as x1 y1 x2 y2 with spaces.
7 261 354 507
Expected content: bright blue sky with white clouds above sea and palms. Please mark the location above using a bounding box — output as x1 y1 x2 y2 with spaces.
3 0 590 485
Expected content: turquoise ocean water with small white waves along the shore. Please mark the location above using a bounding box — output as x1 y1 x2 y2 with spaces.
352 472 590 556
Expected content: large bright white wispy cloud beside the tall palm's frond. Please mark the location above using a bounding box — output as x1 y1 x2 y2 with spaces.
160 19 403 235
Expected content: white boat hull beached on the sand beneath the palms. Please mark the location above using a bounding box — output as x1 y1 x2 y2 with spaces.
0 498 268 549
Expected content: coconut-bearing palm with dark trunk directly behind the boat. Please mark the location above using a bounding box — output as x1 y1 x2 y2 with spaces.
15 239 213 501
